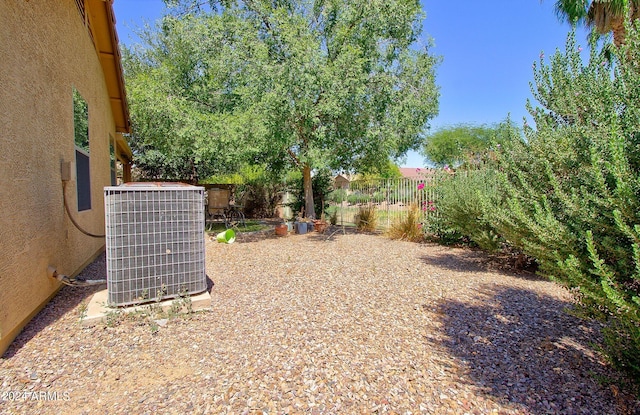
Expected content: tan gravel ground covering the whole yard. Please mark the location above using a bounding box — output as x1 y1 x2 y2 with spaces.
0 232 638 414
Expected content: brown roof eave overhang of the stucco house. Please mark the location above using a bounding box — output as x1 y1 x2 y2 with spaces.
85 0 132 160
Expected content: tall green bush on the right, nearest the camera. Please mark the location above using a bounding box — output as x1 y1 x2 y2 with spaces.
494 25 640 379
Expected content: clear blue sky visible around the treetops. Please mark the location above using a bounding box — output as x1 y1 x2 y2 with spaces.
114 0 587 167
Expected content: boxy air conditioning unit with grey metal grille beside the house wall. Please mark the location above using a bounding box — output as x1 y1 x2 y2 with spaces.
104 183 207 306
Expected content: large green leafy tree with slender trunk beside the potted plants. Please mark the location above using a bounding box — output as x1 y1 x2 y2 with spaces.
128 0 438 217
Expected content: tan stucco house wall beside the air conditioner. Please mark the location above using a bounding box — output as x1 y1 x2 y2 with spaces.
0 0 115 354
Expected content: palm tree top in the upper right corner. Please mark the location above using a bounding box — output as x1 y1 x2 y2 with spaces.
555 0 640 46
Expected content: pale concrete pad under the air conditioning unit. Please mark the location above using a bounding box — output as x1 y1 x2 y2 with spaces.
80 289 211 326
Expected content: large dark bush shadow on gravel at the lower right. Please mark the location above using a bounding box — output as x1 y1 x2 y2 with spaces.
436 286 640 414
